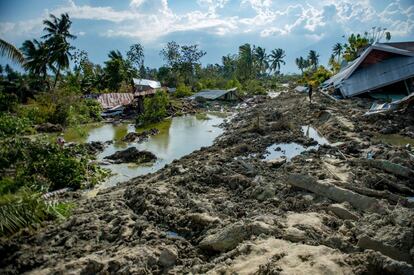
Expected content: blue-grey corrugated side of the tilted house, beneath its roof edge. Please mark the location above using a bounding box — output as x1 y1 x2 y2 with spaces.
339 56 414 97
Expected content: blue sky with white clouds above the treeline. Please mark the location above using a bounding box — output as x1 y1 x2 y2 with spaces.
0 0 414 73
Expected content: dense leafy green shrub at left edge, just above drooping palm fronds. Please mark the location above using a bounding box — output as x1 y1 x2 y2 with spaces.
0 138 105 193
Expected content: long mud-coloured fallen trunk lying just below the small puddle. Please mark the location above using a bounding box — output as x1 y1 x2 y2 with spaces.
287 174 384 213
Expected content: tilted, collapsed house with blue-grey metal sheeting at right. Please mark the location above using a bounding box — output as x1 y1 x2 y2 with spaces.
321 42 414 101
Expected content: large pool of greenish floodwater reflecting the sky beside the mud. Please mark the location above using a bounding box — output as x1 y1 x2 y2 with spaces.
64 113 227 187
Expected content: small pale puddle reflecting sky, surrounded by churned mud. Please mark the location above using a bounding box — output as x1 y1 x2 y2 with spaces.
265 125 329 161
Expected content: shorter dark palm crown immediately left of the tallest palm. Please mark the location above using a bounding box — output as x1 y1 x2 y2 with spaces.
21 39 49 80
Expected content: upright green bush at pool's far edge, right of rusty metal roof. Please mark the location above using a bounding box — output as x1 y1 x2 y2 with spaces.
137 91 169 125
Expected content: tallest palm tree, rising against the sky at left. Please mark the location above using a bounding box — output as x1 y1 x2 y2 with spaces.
42 13 76 86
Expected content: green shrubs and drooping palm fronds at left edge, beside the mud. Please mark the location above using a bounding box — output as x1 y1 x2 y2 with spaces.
0 137 107 236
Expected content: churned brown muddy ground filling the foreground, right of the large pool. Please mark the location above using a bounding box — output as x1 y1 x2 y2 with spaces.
0 89 414 274
